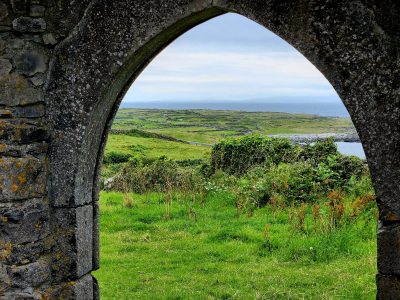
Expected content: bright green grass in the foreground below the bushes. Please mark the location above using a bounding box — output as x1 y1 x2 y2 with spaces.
95 192 376 299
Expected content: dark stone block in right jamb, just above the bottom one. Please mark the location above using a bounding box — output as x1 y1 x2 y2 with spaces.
378 222 400 275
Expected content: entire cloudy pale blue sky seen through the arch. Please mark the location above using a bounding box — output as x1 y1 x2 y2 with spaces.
123 13 340 102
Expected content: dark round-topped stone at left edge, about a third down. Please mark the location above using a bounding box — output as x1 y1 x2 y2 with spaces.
0 73 43 106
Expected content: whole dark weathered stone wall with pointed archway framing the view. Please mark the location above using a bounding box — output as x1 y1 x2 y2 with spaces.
0 0 400 299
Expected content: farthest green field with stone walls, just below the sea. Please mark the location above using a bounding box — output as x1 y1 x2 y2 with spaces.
113 108 354 143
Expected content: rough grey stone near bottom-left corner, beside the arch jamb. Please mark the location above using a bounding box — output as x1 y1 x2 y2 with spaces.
7 258 51 288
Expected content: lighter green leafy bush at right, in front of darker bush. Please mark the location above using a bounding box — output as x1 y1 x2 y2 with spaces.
232 155 373 206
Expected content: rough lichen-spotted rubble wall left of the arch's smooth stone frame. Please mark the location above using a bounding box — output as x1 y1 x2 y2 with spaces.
0 0 93 299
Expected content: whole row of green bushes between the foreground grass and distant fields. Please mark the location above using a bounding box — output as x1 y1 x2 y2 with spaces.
107 135 372 210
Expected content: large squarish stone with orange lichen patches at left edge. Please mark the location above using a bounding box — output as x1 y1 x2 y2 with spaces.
0 156 47 203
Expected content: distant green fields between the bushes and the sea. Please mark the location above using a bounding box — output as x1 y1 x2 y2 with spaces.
106 109 354 165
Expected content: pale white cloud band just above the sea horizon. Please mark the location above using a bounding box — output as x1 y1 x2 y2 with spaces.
127 49 332 101
